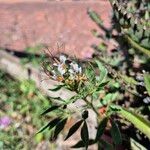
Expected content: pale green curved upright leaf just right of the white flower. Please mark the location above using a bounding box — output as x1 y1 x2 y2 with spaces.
96 60 108 83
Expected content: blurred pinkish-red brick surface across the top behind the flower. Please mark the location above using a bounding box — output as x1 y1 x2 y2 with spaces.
0 0 111 58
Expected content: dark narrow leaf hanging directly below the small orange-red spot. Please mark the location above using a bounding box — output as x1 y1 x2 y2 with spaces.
95 117 108 141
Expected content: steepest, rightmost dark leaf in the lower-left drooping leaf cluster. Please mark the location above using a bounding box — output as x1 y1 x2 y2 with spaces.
53 118 68 140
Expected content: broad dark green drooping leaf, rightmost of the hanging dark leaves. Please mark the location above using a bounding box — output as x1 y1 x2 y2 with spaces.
110 121 122 145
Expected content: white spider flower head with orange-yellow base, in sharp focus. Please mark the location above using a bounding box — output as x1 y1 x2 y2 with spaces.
47 55 86 89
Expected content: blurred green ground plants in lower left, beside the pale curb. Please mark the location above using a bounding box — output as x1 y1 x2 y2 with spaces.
0 70 51 150
